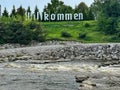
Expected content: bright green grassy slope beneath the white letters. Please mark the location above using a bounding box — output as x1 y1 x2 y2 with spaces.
41 21 111 43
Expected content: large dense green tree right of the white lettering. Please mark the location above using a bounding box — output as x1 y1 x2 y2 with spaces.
94 0 120 34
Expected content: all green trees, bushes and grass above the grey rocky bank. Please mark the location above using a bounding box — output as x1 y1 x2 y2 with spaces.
0 0 120 44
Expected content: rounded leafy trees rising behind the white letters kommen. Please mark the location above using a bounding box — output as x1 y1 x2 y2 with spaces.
43 0 94 20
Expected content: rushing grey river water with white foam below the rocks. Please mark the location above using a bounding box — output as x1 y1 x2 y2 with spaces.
0 60 120 90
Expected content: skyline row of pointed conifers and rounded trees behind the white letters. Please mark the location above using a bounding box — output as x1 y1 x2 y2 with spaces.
2 0 94 21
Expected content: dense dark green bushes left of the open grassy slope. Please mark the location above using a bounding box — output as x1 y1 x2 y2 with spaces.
0 17 45 44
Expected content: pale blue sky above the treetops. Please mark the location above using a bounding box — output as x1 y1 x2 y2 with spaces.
0 0 94 12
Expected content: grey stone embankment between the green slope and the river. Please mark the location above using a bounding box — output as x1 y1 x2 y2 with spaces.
0 43 120 62
